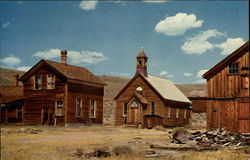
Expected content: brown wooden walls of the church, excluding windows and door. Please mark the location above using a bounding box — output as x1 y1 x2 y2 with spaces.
115 76 190 127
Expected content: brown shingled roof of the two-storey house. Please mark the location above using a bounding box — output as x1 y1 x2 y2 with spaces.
20 60 106 85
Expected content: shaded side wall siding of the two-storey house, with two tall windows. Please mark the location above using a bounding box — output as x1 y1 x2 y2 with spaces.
66 83 104 124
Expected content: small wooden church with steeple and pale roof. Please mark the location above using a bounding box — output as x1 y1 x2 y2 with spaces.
114 49 191 128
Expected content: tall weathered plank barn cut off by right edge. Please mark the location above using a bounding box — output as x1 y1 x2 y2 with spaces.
203 42 250 132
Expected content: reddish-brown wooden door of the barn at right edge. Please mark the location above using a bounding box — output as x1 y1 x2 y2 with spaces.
239 101 250 133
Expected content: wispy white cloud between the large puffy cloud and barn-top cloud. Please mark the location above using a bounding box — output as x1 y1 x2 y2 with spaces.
181 29 224 54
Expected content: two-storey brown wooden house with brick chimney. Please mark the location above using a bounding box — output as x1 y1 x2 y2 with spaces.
20 51 105 125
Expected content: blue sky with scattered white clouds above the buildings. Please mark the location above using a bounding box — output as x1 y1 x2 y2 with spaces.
0 0 249 84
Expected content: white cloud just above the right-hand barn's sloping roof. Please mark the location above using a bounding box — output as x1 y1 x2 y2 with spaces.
216 37 245 55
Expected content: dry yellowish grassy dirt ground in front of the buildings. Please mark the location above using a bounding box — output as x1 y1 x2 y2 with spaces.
1 125 250 160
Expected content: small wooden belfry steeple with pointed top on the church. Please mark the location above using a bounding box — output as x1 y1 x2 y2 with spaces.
136 47 148 77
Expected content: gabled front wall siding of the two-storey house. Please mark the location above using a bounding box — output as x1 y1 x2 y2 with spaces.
23 68 66 124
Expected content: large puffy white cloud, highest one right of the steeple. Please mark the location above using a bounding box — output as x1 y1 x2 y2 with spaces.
155 13 203 36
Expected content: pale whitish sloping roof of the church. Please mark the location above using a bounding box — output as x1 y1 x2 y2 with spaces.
144 75 191 103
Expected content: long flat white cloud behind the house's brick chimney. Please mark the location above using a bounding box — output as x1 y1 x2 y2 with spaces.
33 49 108 64
